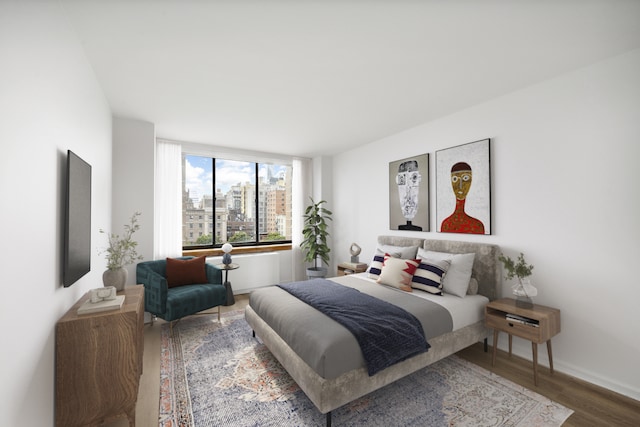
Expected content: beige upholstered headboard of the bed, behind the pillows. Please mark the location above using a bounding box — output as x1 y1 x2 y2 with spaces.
378 236 502 300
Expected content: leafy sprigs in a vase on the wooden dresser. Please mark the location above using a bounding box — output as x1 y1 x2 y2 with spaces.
100 212 143 291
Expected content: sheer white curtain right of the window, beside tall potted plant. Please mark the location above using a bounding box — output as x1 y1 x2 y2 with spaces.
291 158 312 281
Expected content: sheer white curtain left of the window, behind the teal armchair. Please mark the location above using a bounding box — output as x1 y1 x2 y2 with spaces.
153 140 182 259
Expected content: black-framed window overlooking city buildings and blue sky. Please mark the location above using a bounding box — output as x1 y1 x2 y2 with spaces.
182 154 292 249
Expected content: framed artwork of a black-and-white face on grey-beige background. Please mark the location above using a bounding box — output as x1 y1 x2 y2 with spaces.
389 154 429 231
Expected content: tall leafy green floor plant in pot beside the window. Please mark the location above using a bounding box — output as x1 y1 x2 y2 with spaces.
300 198 333 278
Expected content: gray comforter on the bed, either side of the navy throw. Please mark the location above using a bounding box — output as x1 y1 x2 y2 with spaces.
249 276 453 379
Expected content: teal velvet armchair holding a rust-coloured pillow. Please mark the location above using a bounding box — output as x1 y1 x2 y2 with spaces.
136 257 227 322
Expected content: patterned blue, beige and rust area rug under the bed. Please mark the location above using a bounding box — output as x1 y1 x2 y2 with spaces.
159 311 573 427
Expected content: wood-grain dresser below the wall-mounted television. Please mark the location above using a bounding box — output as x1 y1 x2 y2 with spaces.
55 286 144 427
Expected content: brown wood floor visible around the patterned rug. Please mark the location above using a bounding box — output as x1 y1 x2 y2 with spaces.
105 295 640 427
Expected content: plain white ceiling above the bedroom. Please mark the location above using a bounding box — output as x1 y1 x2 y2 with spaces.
61 0 640 157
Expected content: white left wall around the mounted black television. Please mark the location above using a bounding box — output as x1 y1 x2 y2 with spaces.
0 2 111 427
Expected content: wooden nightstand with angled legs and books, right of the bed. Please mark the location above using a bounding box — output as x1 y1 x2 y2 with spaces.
485 298 560 385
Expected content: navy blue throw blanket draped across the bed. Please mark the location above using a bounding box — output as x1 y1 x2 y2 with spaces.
278 279 430 376
